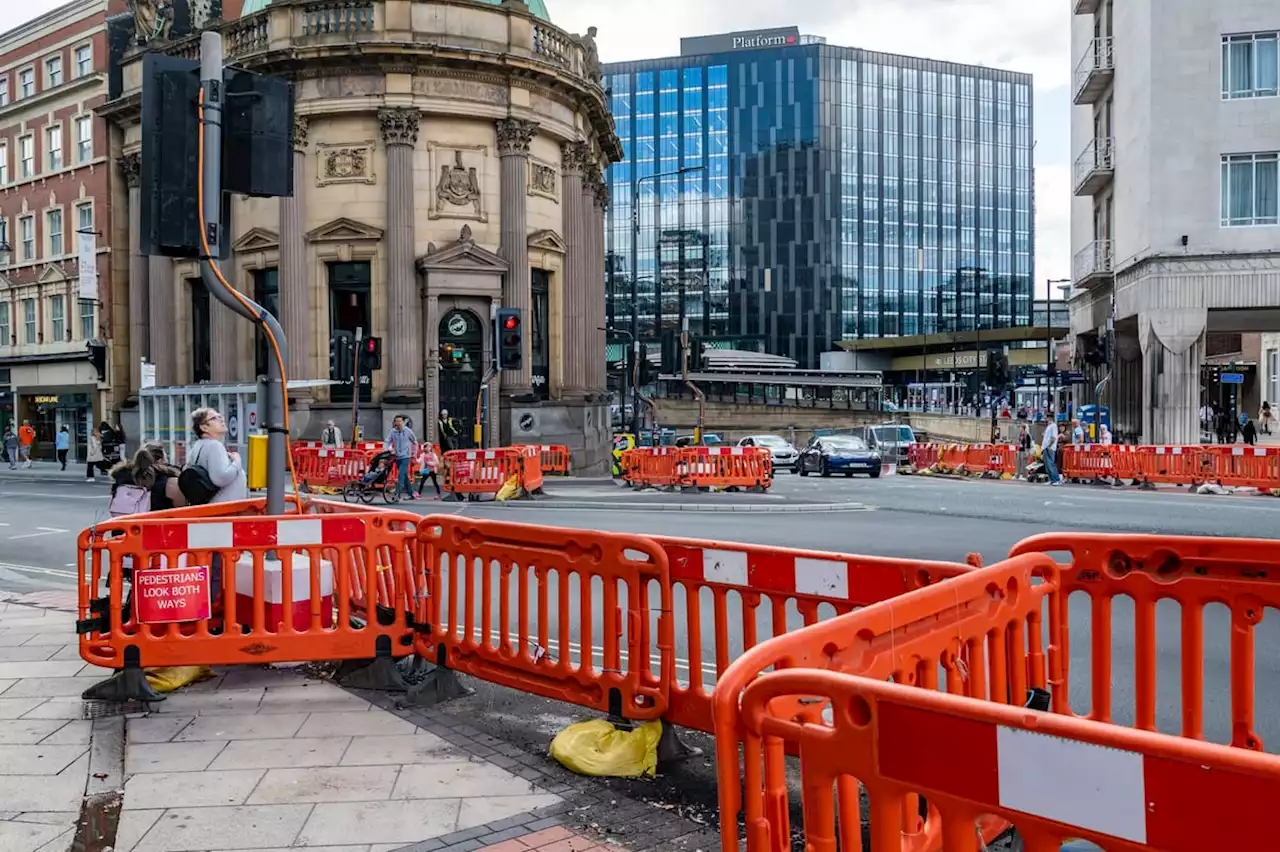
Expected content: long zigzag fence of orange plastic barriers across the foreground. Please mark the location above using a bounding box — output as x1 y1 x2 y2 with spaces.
78 500 1280 852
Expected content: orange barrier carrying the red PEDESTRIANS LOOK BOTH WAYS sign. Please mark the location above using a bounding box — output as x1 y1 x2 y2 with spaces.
77 500 421 690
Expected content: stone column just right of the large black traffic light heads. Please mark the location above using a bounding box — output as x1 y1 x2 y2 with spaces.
279 115 312 379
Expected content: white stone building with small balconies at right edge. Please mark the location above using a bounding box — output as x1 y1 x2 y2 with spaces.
1070 0 1280 444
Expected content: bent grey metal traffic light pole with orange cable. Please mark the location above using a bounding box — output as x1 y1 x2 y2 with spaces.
200 29 288 514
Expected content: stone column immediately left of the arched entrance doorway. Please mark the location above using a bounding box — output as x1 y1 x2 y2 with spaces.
378 109 422 403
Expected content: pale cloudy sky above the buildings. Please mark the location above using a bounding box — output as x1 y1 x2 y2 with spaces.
0 0 1073 294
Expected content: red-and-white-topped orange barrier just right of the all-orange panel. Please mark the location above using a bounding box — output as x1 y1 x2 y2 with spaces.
653 536 972 733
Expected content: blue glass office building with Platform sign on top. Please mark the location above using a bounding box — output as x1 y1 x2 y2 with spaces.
604 28 1036 367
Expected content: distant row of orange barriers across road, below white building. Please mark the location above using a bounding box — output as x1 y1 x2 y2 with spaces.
910 444 1280 495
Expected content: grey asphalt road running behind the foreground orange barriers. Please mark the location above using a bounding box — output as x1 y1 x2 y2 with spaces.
0 475 1280 751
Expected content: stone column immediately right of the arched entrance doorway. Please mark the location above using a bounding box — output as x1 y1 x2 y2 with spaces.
498 118 538 395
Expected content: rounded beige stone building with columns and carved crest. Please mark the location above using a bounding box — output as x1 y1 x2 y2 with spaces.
102 0 622 469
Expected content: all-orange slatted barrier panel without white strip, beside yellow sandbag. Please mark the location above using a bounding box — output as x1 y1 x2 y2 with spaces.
415 516 675 719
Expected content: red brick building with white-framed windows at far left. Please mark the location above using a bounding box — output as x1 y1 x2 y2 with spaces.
0 0 241 459
